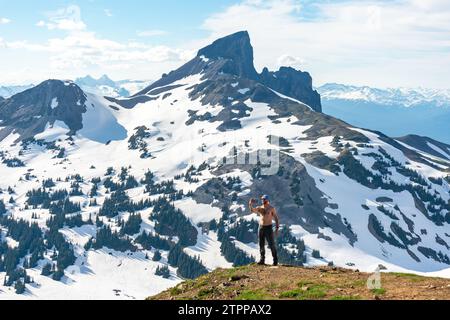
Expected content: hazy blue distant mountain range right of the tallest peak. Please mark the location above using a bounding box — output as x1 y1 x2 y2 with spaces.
317 84 450 143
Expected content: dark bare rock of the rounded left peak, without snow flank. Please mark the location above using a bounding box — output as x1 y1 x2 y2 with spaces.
0 80 86 140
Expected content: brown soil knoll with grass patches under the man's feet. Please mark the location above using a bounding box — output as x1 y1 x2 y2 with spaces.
149 265 450 300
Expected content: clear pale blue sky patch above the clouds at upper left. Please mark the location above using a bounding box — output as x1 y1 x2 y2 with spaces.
0 0 235 44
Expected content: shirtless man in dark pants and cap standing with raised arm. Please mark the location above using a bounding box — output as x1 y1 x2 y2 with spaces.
249 195 280 266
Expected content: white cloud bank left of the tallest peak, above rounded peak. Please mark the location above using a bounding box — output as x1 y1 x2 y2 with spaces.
4 6 193 76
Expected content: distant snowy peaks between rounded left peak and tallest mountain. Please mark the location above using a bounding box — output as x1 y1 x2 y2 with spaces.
75 75 151 98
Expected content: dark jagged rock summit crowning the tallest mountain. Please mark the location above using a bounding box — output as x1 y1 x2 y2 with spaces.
134 31 322 112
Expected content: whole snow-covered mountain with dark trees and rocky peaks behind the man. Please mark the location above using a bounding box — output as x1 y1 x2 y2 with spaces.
0 32 450 299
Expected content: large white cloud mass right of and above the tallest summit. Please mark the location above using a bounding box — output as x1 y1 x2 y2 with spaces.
203 0 450 87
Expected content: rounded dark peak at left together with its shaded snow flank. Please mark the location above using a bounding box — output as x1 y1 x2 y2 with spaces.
0 80 127 143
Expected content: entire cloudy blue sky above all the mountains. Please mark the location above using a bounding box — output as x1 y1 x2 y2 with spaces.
0 0 450 88
